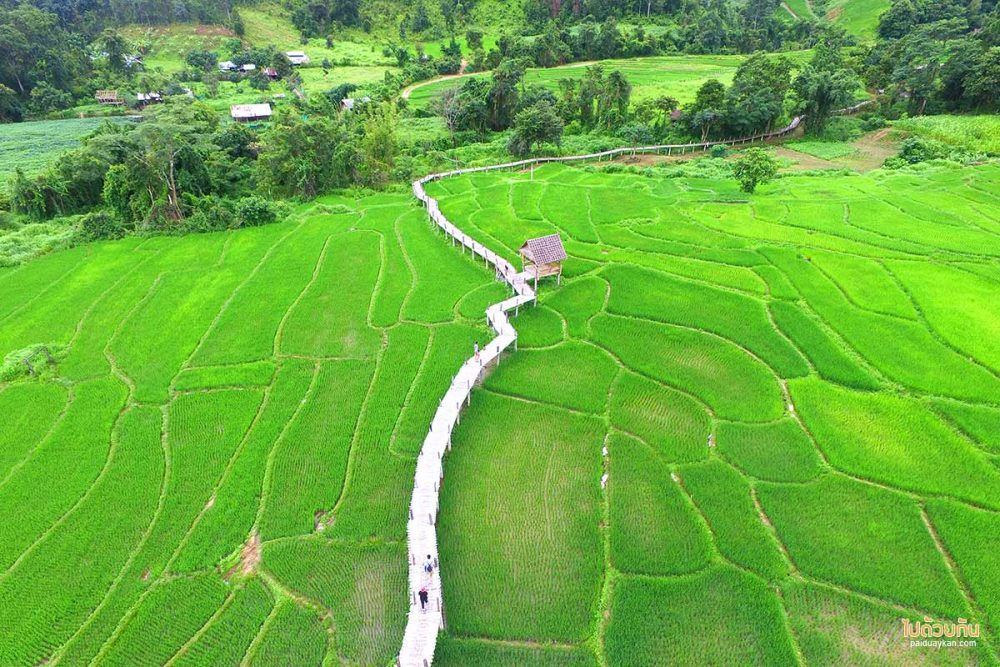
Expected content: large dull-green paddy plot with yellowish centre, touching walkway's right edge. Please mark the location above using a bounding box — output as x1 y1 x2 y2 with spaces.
438 394 603 642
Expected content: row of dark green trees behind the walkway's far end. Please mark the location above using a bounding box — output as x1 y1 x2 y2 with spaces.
435 44 861 155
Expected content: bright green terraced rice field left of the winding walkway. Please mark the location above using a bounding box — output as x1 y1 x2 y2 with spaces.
0 190 505 666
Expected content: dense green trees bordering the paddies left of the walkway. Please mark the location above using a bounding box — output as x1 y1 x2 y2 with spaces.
10 97 399 238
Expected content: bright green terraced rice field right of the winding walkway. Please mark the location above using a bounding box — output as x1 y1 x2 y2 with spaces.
429 165 1000 667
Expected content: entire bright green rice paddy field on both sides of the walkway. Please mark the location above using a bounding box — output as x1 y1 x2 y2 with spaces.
0 158 1000 667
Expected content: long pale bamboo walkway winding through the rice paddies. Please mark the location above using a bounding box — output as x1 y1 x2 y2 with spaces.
398 111 860 667
